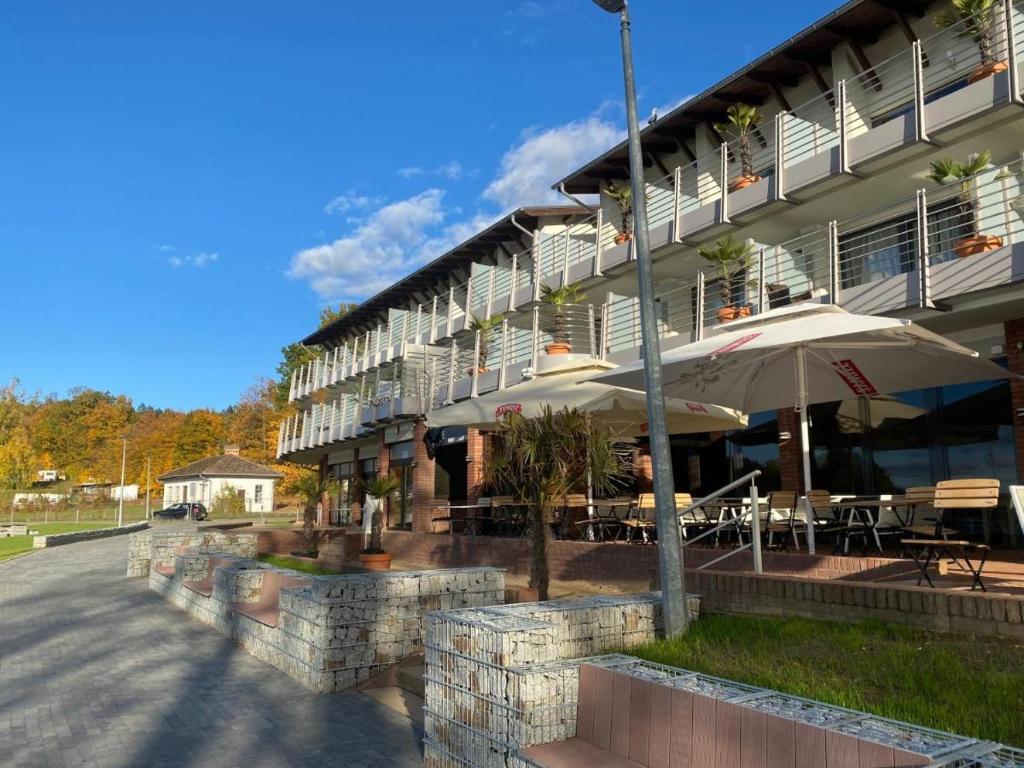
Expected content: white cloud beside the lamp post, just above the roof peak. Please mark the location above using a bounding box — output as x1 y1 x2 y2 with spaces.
483 116 625 210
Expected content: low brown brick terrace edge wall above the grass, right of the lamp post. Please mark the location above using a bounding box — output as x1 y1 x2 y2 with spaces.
686 571 1024 640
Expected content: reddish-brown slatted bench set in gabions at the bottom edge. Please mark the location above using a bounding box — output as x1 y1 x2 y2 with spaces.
520 664 932 768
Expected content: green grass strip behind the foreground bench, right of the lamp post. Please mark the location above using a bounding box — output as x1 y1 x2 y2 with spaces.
627 615 1024 746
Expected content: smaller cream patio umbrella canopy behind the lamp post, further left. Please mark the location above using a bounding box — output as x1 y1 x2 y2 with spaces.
427 360 746 437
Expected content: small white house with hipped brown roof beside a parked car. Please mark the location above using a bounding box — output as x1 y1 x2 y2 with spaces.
157 447 284 514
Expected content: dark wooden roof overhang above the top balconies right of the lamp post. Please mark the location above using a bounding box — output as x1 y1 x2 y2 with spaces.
553 0 932 195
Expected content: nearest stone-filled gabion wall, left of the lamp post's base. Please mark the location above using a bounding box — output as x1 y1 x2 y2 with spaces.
424 593 700 766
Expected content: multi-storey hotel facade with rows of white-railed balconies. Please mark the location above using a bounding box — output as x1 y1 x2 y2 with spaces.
279 0 1024 544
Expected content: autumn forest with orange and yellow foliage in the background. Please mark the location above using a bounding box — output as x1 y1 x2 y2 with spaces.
0 304 354 494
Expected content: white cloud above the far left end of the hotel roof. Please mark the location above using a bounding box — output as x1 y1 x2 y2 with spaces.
288 188 447 300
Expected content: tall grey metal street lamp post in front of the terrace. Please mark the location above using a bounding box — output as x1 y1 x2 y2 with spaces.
594 0 688 637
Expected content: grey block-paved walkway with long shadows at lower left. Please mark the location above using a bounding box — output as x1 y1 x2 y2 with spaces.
0 537 422 768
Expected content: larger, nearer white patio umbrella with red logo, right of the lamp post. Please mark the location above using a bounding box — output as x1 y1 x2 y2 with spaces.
591 304 1012 553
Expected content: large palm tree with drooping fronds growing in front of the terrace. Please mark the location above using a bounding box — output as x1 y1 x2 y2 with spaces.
484 406 632 600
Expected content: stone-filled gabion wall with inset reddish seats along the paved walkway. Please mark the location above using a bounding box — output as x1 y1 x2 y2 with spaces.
150 550 505 693
